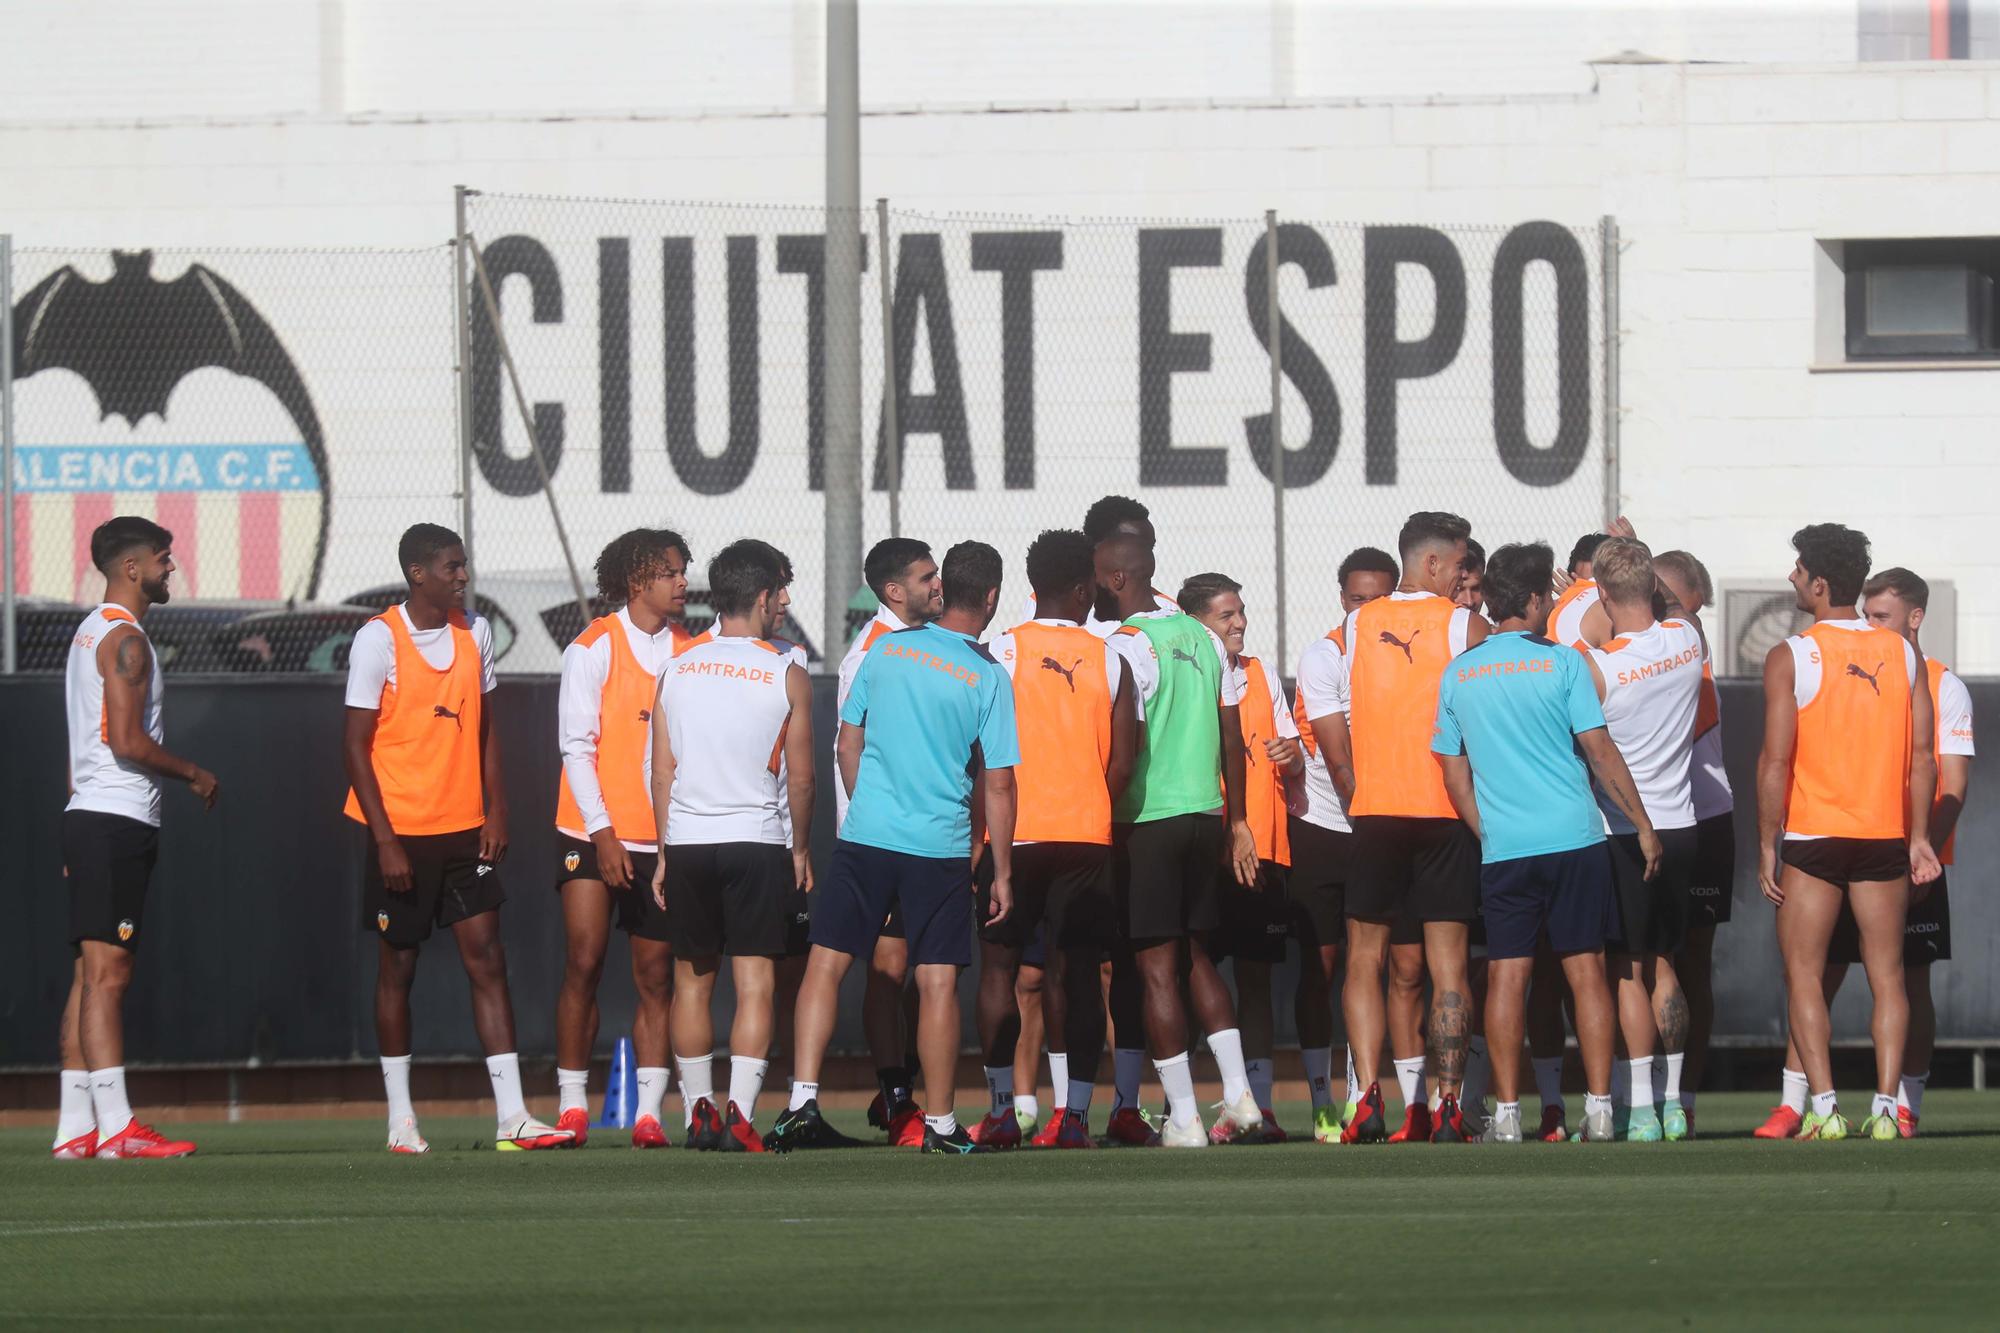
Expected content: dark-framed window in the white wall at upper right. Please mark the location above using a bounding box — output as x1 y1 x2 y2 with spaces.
1842 236 2000 360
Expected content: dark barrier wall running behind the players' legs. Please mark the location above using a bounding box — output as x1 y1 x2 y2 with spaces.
0 677 2000 1067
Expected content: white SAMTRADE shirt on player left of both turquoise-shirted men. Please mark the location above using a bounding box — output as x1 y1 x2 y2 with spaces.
654 636 792 847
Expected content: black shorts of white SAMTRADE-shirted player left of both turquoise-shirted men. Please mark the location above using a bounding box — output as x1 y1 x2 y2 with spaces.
648 843 798 959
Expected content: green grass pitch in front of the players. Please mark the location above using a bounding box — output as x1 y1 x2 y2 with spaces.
0 1093 2000 1329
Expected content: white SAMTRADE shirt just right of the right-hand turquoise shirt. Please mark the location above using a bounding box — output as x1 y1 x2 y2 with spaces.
1588 620 1702 833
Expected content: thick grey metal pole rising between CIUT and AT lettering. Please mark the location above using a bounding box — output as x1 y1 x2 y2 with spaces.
822 0 862 660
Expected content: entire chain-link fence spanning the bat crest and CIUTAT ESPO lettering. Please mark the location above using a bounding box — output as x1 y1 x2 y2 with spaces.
8 202 1616 673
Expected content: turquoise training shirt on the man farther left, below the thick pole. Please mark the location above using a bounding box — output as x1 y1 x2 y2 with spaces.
836 624 1020 859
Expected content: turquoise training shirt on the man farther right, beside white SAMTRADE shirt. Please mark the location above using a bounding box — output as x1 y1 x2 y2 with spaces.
1430 630 1604 865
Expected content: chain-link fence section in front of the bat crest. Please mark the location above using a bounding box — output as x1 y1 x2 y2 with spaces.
6 246 458 673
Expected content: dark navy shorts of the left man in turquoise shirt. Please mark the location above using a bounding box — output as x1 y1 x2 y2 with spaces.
812 839 972 967
